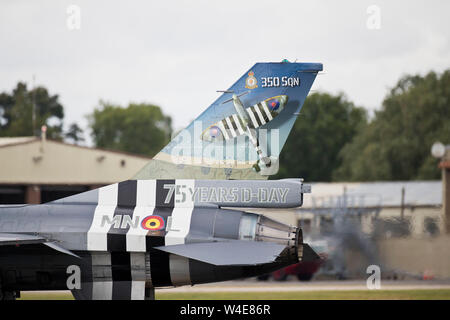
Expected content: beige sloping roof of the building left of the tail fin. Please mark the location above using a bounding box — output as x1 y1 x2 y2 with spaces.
0 137 151 185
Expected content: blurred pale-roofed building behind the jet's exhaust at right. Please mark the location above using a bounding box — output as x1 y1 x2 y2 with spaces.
258 181 450 279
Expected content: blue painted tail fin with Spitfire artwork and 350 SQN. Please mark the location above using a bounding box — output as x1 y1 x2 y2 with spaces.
134 60 322 179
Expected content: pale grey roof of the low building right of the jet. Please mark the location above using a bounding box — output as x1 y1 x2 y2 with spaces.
303 181 442 208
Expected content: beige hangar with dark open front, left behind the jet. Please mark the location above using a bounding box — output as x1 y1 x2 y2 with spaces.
0 137 151 204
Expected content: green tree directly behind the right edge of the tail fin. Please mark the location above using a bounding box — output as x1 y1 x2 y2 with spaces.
274 93 367 181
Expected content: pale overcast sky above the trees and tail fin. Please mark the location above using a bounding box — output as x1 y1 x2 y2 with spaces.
0 0 450 144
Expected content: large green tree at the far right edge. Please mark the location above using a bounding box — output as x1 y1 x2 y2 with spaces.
333 70 450 181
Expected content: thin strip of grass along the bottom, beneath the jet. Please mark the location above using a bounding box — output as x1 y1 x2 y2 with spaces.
16 289 450 300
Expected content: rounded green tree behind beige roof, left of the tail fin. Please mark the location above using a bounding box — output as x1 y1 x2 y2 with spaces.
88 101 172 156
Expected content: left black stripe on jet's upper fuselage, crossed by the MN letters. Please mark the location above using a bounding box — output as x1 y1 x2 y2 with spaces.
107 180 137 252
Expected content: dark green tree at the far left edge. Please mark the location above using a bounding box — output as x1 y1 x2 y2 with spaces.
0 82 64 140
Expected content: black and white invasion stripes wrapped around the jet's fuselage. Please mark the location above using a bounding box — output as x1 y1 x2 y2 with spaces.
83 179 199 299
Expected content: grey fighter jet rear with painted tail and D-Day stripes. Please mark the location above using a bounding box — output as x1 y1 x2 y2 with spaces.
0 61 322 300
